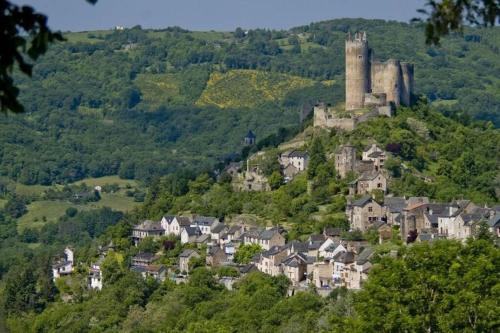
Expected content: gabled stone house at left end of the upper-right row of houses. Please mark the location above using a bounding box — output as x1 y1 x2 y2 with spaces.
346 196 385 231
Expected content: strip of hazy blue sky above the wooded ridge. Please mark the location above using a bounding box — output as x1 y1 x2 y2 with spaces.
12 0 426 31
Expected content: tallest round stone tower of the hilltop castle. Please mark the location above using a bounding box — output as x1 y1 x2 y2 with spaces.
345 33 370 110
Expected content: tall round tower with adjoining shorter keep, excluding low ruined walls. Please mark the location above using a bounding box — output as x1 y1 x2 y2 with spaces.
345 32 413 111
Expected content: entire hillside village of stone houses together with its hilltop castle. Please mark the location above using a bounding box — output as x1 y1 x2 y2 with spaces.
53 33 500 295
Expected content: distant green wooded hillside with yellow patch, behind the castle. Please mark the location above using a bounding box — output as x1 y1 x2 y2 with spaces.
0 19 500 185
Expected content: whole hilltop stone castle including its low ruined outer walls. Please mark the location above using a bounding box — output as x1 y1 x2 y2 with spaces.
314 32 413 130
